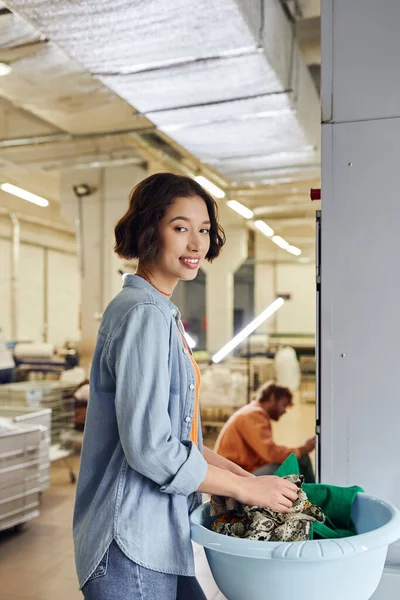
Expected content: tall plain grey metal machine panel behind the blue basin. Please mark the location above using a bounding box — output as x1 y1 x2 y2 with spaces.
317 0 400 600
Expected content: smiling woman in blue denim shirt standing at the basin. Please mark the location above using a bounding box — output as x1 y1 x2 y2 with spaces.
74 173 297 600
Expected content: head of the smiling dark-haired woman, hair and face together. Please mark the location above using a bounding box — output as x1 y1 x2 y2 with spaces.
115 173 225 294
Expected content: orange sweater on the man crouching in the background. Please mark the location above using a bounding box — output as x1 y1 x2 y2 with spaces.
215 401 305 472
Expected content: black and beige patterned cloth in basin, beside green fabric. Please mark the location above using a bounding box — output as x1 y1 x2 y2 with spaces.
210 475 325 542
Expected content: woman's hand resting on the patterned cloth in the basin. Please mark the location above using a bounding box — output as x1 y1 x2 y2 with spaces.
234 475 298 513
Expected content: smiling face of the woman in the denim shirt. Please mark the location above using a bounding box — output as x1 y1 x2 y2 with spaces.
156 196 210 281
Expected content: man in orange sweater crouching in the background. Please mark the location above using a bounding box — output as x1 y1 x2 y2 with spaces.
215 382 315 483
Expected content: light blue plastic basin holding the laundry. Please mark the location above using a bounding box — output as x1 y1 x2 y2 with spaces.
190 494 400 600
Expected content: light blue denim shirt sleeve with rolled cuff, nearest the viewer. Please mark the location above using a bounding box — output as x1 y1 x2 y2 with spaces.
108 303 207 496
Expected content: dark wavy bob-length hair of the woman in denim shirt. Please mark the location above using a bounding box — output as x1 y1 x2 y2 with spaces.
114 173 225 263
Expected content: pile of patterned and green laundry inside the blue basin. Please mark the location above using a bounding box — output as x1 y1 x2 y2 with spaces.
210 454 363 542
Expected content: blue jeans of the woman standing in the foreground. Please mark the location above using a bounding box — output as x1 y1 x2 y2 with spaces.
82 541 207 600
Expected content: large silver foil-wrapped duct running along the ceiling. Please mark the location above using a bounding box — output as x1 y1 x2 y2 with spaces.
4 0 320 183
